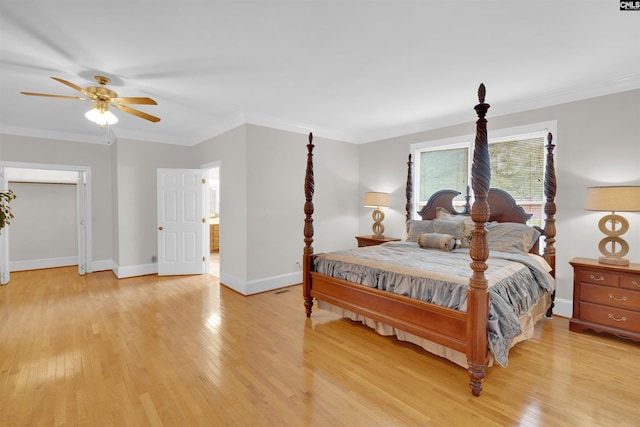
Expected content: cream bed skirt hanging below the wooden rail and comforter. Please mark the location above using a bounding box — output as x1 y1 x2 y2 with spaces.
318 292 551 369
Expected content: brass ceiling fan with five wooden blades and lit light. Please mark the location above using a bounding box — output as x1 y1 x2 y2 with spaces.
20 76 160 127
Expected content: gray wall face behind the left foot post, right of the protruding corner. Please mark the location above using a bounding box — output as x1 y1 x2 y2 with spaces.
247 126 358 280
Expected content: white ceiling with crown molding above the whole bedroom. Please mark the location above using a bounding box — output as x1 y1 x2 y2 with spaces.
0 0 640 145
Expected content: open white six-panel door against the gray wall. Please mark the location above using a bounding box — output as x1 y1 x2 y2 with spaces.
157 169 209 276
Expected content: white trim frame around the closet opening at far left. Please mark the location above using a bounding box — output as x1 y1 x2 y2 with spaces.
0 161 93 285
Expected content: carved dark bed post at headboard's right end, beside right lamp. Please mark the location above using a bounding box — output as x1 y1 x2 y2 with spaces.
543 132 556 317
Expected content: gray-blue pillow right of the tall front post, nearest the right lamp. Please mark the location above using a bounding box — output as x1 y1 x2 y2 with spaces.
486 222 541 253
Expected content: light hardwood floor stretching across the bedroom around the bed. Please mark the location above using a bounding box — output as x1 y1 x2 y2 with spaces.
0 268 640 427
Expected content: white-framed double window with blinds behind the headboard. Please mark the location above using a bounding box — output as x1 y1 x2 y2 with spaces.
412 122 555 227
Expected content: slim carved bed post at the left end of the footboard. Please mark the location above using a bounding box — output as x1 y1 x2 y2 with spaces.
302 133 315 317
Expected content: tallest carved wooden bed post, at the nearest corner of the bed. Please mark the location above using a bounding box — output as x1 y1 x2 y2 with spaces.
467 84 491 396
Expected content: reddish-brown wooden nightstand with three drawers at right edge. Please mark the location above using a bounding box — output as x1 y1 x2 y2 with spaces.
569 258 640 341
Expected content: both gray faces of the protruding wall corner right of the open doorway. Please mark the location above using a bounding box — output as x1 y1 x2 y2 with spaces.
191 125 358 292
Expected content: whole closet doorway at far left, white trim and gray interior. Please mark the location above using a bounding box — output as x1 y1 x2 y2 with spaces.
0 162 92 285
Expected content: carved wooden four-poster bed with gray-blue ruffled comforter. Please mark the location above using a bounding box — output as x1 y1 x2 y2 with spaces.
303 85 556 396
